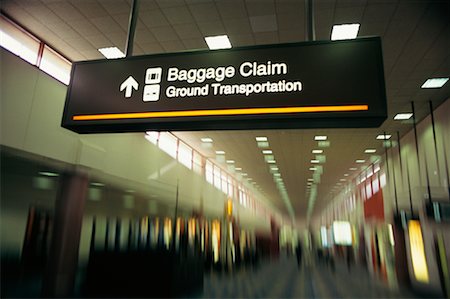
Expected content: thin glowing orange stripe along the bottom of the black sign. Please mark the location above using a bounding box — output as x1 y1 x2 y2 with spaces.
72 105 369 120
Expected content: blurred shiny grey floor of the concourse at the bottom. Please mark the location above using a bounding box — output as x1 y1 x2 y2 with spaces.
202 257 419 298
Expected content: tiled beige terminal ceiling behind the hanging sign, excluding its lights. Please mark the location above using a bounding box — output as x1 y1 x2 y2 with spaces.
1 0 450 225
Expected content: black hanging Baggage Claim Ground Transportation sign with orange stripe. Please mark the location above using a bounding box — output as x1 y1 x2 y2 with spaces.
62 37 387 133
